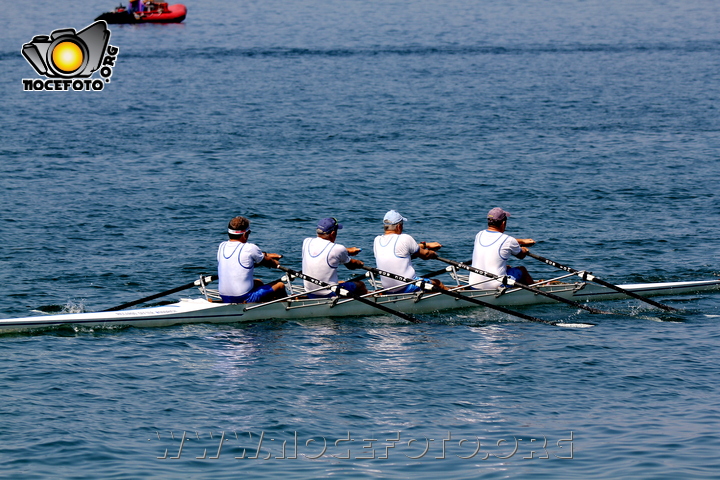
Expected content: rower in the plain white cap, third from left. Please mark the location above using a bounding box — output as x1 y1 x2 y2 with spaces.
373 210 445 293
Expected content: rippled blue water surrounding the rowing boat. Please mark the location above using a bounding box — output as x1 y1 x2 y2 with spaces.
0 0 720 479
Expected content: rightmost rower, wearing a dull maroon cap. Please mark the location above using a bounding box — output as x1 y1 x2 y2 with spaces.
469 207 535 290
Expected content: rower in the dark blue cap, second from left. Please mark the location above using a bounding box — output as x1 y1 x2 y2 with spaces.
302 218 367 298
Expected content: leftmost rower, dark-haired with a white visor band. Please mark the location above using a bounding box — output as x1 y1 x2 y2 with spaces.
217 217 286 303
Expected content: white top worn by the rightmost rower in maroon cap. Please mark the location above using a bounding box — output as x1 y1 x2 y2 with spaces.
469 230 521 290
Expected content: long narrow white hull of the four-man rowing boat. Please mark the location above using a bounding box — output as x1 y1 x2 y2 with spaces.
0 280 720 333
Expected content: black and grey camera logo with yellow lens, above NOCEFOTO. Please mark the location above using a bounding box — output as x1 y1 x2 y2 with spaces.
22 20 110 79
